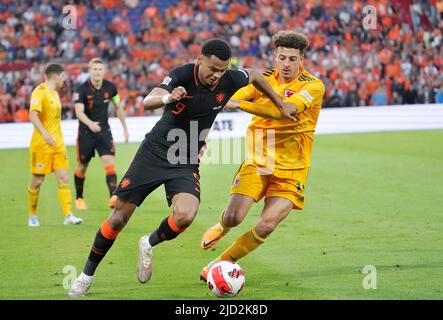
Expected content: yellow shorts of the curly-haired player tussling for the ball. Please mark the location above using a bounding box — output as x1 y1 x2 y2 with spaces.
230 162 309 210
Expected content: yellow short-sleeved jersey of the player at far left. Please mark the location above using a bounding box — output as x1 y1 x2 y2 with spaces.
29 83 66 153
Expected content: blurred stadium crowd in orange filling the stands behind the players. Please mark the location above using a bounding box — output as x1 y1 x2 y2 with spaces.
0 0 443 122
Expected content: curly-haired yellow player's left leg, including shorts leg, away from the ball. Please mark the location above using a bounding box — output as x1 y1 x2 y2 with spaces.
200 163 269 250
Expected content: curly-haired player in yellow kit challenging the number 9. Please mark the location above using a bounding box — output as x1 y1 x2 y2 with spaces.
200 31 325 281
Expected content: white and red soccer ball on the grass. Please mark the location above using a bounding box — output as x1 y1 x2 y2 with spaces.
207 261 245 298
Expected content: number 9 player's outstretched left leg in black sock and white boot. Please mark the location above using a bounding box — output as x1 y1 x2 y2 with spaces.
68 198 137 298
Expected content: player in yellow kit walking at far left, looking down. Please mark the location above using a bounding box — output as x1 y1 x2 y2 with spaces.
28 63 82 227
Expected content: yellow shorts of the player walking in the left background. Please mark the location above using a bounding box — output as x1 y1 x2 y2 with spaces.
30 150 69 174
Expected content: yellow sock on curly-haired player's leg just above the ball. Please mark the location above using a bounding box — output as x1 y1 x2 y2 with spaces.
215 227 266 262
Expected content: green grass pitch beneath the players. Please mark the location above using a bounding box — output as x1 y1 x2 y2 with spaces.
0 130 443 299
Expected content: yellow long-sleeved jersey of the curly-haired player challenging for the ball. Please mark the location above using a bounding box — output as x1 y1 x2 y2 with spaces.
231 67 325 169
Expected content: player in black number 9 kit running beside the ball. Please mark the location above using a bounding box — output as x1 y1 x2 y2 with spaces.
68 39 290 297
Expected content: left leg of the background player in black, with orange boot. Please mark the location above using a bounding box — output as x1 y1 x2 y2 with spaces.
74 134 96 210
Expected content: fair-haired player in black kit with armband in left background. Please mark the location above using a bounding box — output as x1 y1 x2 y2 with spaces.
74 58 129 210
